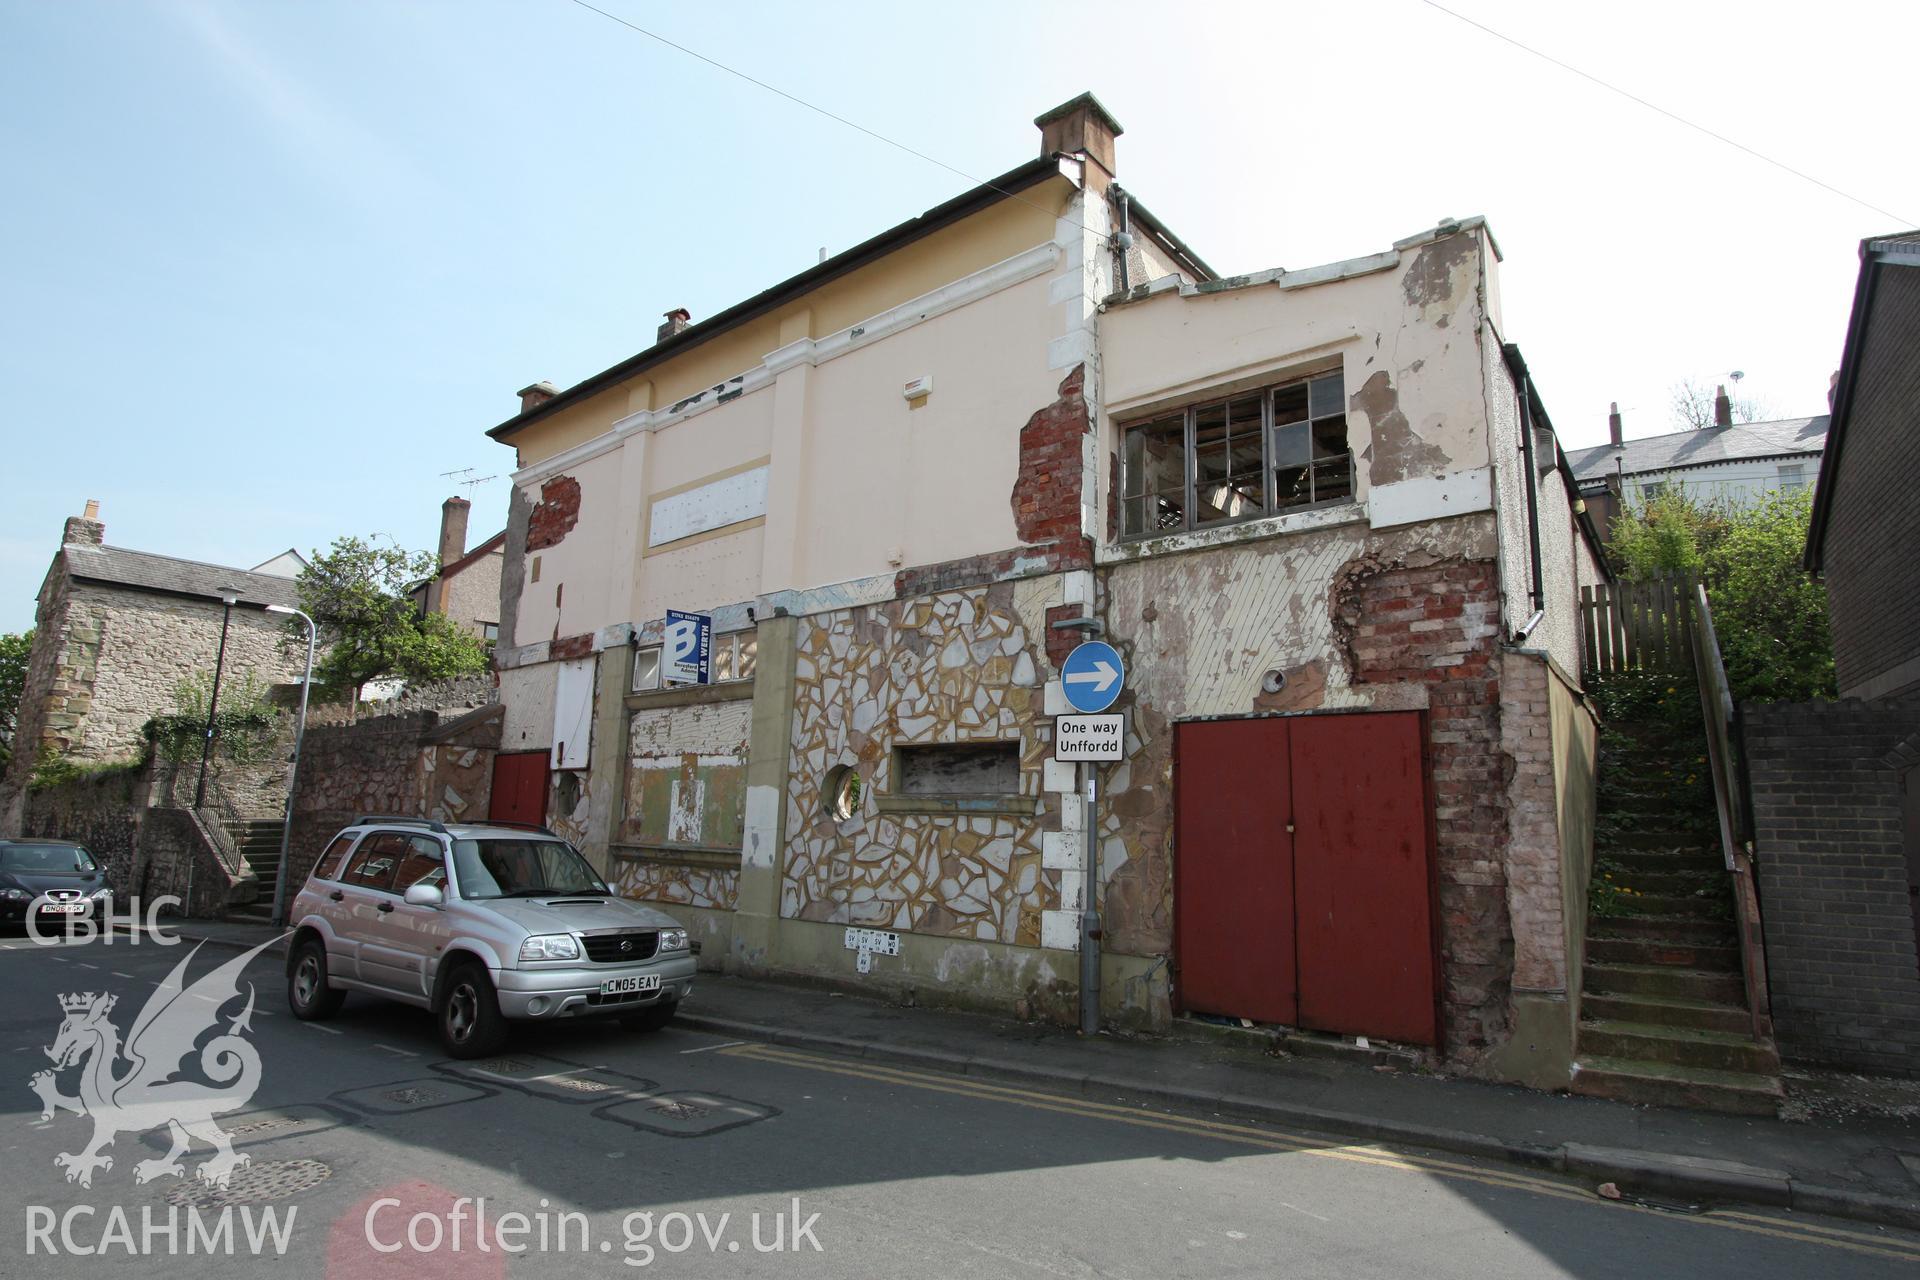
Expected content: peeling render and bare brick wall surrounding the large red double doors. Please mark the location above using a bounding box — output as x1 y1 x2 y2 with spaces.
1100 514 1557 1059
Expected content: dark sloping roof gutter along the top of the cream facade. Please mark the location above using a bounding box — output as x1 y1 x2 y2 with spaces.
488 157 1067 441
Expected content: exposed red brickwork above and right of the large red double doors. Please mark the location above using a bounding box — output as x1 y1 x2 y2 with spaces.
1332 558 1512 1059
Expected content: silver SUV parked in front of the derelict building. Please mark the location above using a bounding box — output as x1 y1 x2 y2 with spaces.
286 818 695 1057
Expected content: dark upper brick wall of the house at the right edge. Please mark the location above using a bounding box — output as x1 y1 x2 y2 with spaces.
1826 267 1920 697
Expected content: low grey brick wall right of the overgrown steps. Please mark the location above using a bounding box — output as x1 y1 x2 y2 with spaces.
1741 700 1920 1075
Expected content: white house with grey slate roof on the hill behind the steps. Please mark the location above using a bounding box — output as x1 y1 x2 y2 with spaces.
1567 401 1828 535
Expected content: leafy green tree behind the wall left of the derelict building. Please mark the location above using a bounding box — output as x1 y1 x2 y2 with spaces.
288 537 490 702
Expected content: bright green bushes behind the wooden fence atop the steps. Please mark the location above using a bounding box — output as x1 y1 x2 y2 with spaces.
1613 489 1836 702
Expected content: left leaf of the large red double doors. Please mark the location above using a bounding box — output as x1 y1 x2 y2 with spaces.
1173 720 1296 1025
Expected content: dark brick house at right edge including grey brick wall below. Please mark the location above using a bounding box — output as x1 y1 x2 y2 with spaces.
1741 232 1920 1075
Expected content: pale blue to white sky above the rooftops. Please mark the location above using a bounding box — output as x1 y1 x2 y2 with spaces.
0 0 1920 629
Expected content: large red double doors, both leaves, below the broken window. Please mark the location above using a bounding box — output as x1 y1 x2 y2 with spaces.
1175 712 1440 1044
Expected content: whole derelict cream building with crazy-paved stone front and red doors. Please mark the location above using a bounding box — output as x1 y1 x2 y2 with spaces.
397 96 1605 1086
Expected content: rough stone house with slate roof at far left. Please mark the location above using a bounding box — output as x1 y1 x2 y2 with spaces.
0 501 305 835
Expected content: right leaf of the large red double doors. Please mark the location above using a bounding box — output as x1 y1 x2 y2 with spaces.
1290 712 1440 1044
